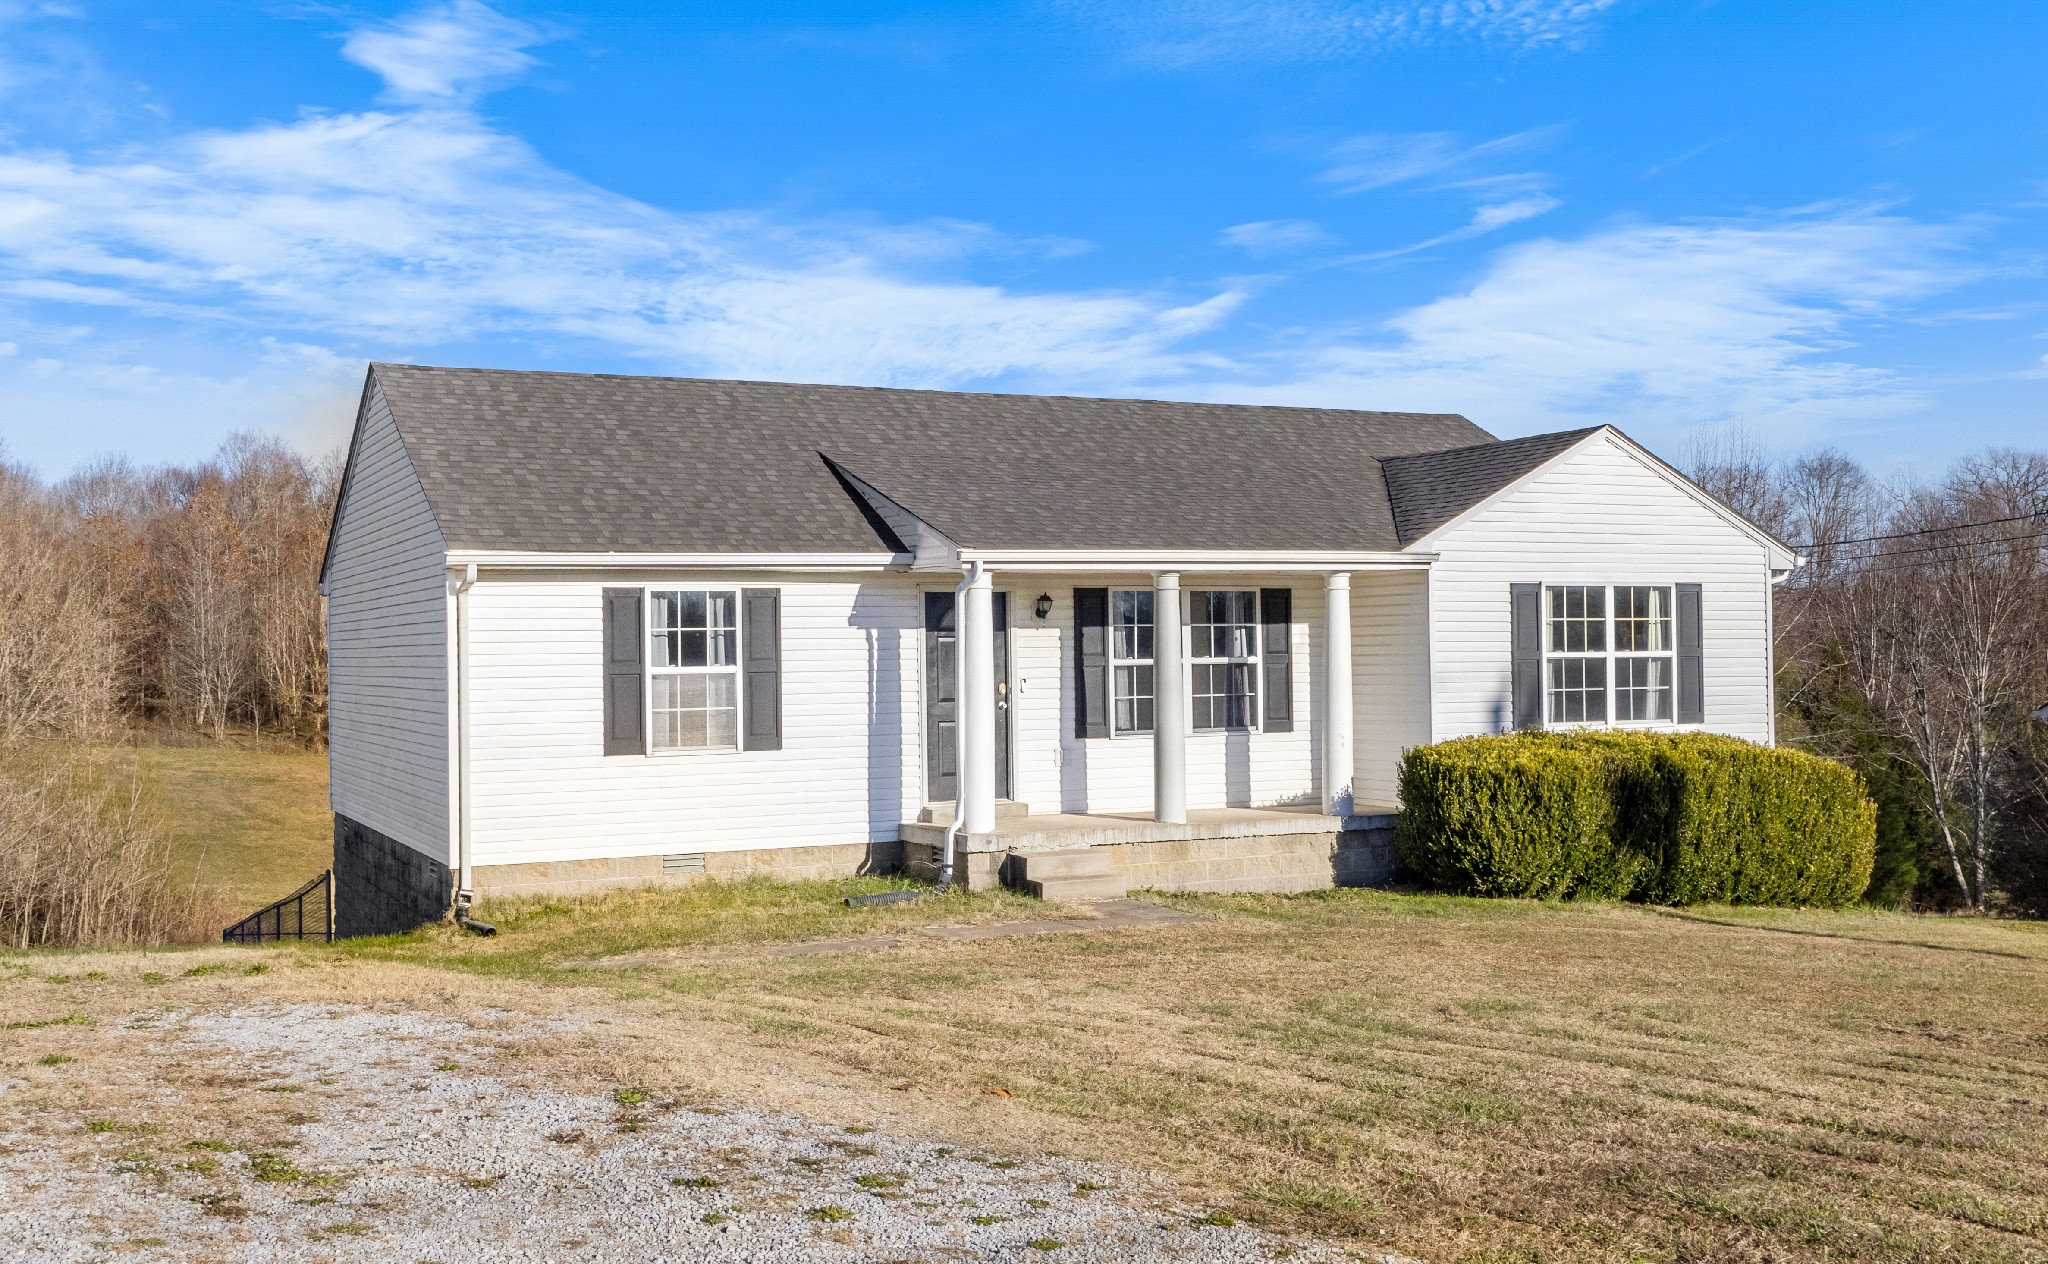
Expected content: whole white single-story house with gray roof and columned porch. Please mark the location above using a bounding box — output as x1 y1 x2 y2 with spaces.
322 365 1798 932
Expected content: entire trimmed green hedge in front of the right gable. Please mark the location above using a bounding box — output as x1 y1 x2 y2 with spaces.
1395 733 1876 905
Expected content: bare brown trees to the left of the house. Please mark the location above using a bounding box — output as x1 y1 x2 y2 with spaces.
0 434 340 742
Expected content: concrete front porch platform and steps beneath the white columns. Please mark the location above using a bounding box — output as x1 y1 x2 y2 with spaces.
901 803 1395 893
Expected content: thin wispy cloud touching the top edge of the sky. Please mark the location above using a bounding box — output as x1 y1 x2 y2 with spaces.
1061 0 1620 66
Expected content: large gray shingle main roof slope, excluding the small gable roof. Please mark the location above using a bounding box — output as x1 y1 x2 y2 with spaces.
371 365 1532 553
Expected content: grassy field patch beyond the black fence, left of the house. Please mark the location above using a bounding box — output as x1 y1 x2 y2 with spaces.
123 740 334 916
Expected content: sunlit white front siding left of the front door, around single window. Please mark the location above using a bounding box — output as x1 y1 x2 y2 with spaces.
469 574 924 865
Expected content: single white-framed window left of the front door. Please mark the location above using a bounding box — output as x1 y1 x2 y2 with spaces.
647 588 739 752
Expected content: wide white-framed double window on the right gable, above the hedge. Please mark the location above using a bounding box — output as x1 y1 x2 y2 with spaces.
1544 584 1677 727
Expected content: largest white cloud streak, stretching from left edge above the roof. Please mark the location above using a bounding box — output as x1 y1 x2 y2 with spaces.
0 2 1241 385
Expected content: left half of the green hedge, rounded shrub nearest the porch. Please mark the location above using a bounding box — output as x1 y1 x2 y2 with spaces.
1395 733 1647 899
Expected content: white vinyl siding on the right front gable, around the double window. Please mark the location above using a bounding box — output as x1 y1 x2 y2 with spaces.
1425 434 1772 742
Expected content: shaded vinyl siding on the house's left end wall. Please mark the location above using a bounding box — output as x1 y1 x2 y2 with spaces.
328 387 451 860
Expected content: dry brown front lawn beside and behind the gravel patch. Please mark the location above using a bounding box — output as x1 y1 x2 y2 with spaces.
16 893 2048 1264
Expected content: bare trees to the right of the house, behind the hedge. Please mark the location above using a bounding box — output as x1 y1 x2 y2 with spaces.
1690 438 2048 916
